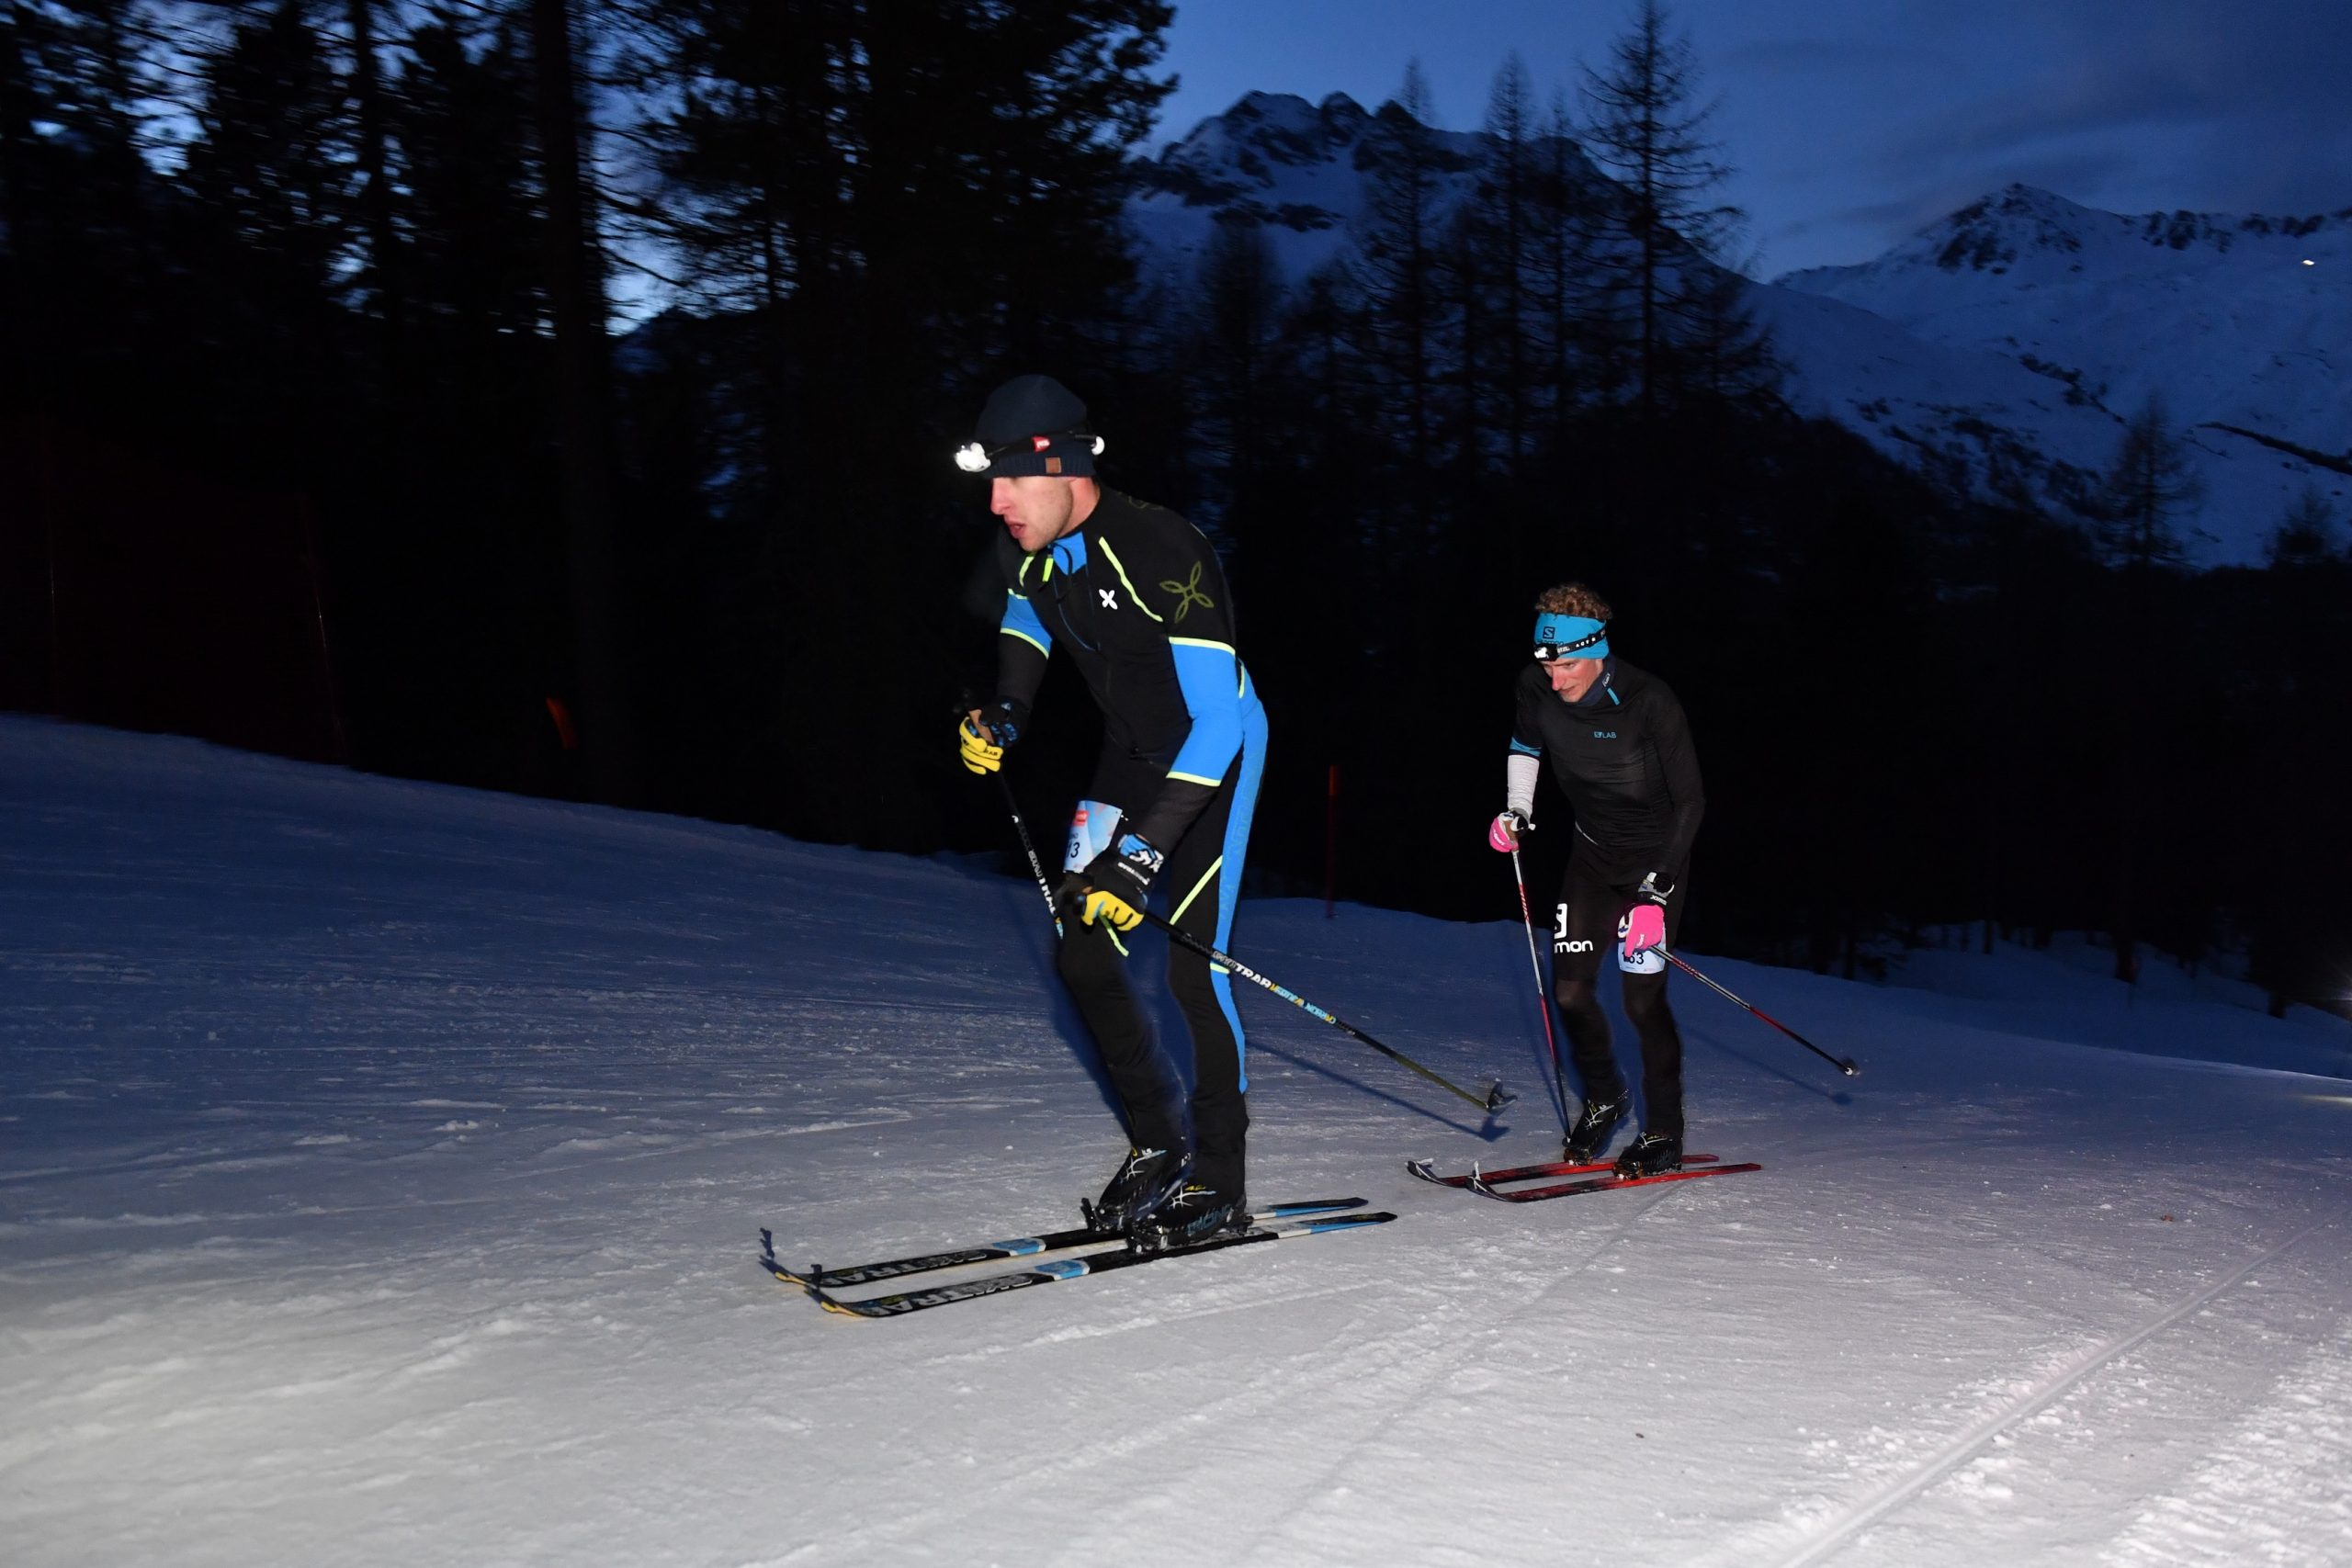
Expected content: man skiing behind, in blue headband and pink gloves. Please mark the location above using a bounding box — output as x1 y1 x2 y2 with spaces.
1487 583 1708 1176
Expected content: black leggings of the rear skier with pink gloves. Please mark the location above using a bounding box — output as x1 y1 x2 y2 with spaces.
1553 840 1689 1138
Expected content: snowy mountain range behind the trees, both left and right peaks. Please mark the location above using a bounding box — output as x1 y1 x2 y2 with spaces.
1126 92 2352 567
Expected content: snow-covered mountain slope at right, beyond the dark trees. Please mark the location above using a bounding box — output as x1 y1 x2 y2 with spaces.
1778 186 2352 559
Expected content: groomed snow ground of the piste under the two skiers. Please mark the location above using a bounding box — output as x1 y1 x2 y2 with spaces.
14 719 2352 1568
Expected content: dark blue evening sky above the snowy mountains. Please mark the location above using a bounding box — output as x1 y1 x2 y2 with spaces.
1162 0 2352 277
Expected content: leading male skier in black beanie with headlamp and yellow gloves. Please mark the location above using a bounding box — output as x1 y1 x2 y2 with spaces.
955 376 1265 1246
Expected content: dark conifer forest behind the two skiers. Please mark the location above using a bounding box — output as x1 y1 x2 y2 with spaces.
0 0 2352 1009
